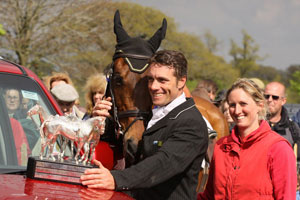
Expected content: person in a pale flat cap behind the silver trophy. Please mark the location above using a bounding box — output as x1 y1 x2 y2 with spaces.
51 83 84 119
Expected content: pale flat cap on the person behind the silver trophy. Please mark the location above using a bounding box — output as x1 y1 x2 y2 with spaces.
51 83 79 102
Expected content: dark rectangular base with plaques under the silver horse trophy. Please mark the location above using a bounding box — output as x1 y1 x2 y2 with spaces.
27 157 97 185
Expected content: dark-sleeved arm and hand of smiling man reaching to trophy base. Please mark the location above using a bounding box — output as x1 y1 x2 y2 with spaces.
81 115 208 190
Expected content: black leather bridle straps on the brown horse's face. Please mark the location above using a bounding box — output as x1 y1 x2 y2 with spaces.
107 50 150 136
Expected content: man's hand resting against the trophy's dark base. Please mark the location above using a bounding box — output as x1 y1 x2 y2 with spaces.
80 160 115 190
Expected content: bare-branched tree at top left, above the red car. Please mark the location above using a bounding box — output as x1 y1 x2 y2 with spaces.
0 0 70 72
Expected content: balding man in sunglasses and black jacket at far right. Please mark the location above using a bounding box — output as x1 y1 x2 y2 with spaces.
264 82 300 162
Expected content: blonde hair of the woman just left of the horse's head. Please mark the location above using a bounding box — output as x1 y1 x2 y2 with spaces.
84 73 107 114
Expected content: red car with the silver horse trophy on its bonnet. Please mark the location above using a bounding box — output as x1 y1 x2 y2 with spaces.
0 57 132 199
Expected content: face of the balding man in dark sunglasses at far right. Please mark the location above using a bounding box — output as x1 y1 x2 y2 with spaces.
264 84 286 116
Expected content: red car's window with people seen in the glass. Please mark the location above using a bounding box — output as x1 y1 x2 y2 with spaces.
0 73 56 173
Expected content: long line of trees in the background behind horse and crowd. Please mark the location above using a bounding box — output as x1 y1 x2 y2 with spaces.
0 0 296 104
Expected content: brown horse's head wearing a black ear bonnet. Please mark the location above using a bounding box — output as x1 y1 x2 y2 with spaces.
110 11 167 164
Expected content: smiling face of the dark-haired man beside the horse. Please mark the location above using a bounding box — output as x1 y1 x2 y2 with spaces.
147 63 186 106
